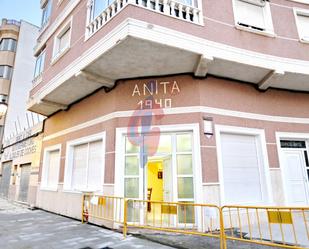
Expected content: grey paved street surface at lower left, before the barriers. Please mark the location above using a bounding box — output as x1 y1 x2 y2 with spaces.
0 199 172 249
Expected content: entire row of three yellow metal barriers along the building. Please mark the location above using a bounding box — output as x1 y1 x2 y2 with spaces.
82 194 309 249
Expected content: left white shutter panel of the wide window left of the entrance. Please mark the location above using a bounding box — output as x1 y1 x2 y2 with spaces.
72 144 88 189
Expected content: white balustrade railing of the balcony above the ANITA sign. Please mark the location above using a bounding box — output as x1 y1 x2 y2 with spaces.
86 0 203 37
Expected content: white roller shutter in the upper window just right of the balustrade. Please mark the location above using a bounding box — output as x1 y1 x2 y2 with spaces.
235 0 266 30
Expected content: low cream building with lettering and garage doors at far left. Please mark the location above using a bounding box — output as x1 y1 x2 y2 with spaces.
0 123 43 206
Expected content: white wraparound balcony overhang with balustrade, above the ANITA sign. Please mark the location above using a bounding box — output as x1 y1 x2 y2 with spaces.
28 0 309 116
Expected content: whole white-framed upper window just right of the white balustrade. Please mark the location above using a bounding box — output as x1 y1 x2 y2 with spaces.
234 0 273 33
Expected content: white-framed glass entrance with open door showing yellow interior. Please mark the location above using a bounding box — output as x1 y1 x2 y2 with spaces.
124 132 195 223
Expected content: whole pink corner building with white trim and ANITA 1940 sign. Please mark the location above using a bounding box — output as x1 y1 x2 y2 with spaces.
28 0 309 222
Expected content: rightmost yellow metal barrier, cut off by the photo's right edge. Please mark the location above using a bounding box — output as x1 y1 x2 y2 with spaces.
221 206 309 248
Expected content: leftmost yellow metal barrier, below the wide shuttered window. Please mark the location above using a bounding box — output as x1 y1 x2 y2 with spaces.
81 194 125 228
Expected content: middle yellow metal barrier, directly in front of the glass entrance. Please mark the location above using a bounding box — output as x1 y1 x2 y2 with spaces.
125 199 224 249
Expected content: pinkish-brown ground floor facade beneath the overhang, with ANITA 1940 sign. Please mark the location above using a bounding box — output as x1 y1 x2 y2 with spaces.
37 75 309 219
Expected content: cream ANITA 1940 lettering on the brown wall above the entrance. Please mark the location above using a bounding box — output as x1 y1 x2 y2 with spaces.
132 80 180 110
